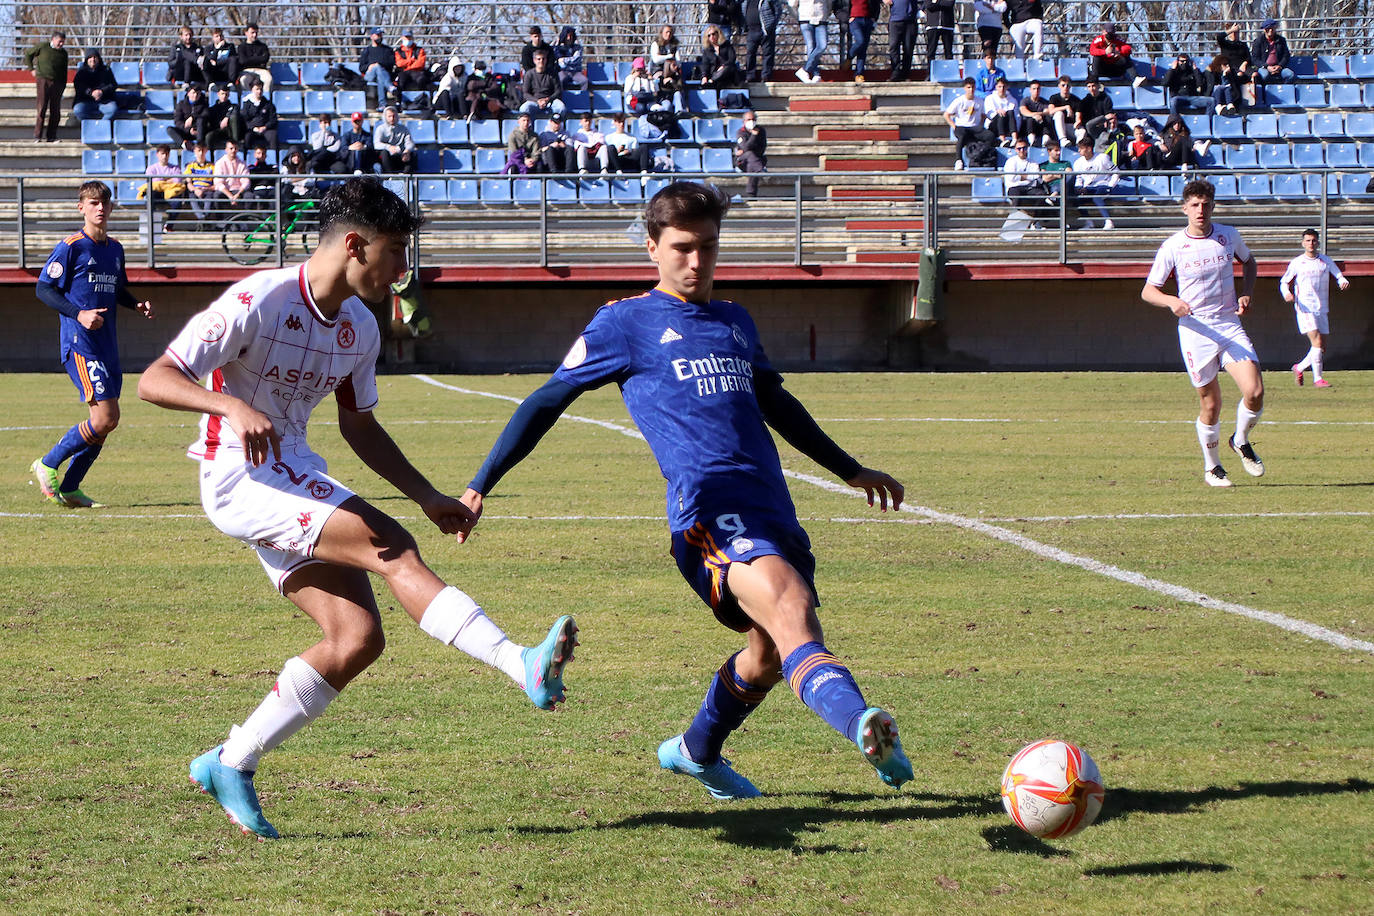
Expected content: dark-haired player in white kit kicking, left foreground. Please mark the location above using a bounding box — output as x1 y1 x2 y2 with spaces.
139 179 577 836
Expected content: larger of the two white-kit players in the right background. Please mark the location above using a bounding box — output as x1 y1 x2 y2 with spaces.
1140 180 1264 486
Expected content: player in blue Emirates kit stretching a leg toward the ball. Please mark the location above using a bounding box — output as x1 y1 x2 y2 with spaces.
458 181 911 799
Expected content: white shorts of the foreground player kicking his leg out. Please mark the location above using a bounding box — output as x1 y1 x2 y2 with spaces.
201 450 353 592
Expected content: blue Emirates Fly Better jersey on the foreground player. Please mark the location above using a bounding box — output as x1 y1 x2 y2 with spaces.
554 288 797 531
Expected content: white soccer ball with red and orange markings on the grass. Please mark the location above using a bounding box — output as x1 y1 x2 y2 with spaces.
1002 737 1105 839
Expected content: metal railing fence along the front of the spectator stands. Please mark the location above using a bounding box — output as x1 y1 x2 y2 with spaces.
0 169 1374 269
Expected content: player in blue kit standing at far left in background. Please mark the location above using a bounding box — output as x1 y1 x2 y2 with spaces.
30 181 153 508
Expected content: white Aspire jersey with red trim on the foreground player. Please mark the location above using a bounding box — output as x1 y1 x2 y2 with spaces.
168 265 382 460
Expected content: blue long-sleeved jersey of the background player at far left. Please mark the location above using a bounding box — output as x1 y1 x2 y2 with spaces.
38 231 128 364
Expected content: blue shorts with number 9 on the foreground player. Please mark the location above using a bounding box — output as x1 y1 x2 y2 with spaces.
673 512 819 633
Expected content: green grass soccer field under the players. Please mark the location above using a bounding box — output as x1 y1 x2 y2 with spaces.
0 372 1374 915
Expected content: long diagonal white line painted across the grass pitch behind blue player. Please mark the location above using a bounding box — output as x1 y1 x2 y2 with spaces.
411 375 1374 654
